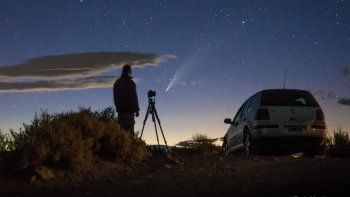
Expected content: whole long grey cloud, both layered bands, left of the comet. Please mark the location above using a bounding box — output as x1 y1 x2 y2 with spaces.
0 52 175 93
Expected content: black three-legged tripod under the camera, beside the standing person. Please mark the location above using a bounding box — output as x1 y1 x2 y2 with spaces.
140 96 169 152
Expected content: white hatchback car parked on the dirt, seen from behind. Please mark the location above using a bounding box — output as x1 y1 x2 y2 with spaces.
222 89 327 157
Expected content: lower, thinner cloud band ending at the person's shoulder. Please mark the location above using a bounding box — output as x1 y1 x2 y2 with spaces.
0 76 116 93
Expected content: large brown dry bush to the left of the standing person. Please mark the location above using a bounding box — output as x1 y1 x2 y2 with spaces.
12 108 148 172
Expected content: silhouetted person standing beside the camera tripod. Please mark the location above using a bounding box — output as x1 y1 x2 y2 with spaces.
113 65 140 134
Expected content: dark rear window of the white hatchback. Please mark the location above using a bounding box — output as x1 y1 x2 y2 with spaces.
261 90 319 107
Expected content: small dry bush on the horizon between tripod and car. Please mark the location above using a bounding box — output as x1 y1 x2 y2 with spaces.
192 133 220 154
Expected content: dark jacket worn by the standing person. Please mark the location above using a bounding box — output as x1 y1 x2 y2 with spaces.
113 75 140 113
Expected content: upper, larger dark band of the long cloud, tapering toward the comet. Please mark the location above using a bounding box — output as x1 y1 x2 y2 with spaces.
0 52 174 82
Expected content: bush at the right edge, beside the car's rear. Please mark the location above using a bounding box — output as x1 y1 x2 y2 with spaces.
328 128 350 158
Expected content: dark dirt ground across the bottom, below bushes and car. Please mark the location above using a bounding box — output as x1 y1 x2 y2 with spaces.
0 154 350 196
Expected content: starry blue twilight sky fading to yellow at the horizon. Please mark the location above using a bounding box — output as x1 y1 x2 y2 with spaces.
0 0 350 145
